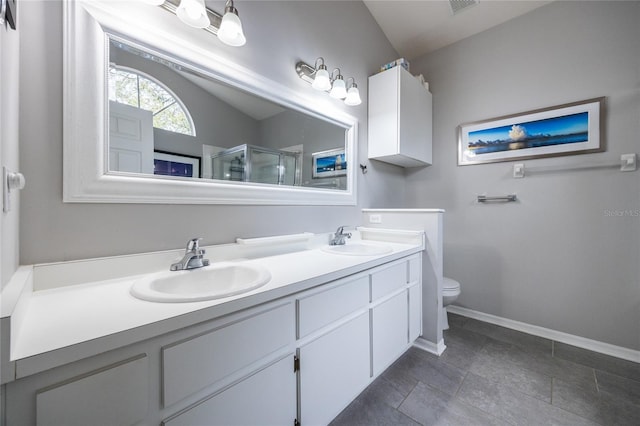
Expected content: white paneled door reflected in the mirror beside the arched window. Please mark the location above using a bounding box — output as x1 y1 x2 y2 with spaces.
109 101 153 174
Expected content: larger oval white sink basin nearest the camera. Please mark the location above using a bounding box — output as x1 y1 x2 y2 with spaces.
131 263 271 302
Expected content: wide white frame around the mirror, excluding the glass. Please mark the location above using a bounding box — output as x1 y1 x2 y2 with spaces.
63 0 358 205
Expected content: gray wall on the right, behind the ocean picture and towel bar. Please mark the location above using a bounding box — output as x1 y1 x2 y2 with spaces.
407 2 640 350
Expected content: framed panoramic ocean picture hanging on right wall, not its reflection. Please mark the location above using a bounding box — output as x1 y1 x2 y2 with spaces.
458 97 606 166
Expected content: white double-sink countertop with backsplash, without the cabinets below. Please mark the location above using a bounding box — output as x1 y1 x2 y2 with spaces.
2 228 424 379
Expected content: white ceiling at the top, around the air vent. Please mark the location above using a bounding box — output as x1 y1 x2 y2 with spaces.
364 0 551 61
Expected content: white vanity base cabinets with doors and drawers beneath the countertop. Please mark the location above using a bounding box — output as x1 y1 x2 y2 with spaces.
4 253 421 426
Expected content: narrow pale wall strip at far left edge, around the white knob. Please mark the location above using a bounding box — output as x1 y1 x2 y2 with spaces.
0 11 20 288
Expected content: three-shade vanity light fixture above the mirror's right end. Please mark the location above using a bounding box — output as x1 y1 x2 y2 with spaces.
296 57 362 106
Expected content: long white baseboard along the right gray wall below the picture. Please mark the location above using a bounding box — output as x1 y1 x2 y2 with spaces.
447 305 640 363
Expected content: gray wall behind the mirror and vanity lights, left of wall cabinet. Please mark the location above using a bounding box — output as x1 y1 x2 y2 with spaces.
20 1 404 264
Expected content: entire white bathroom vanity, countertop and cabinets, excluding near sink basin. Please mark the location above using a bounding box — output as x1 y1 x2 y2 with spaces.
2 230 425 426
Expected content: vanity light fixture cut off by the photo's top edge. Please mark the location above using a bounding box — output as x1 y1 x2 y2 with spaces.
148 0 247 47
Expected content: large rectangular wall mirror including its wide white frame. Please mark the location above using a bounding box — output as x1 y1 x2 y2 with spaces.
64 1 357 205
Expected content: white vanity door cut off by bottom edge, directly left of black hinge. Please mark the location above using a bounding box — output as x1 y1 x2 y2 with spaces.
162 353 296 426
